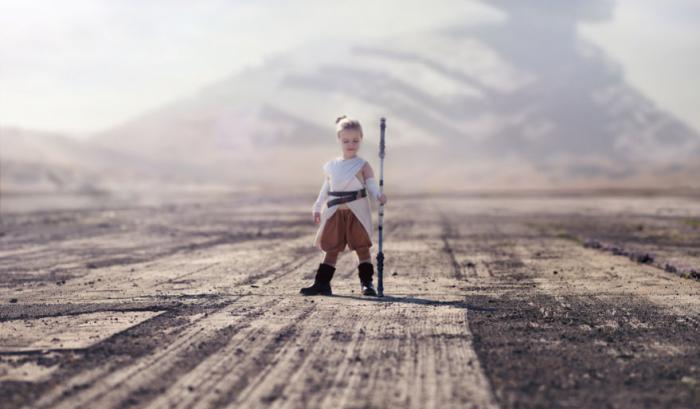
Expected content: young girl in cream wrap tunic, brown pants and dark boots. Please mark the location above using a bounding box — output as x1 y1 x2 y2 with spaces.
301 115 387 295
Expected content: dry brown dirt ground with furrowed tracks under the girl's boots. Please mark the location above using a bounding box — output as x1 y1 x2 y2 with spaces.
0 192 700 408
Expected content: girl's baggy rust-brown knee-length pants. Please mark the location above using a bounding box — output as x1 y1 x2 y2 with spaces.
321 208 372 265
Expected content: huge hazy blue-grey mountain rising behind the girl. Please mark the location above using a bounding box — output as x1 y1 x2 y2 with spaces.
2 0 700 194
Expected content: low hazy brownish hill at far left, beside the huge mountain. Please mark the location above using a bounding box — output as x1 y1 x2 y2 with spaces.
0 127 224 194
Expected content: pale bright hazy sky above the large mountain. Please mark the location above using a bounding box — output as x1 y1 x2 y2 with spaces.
0 0 700 136
